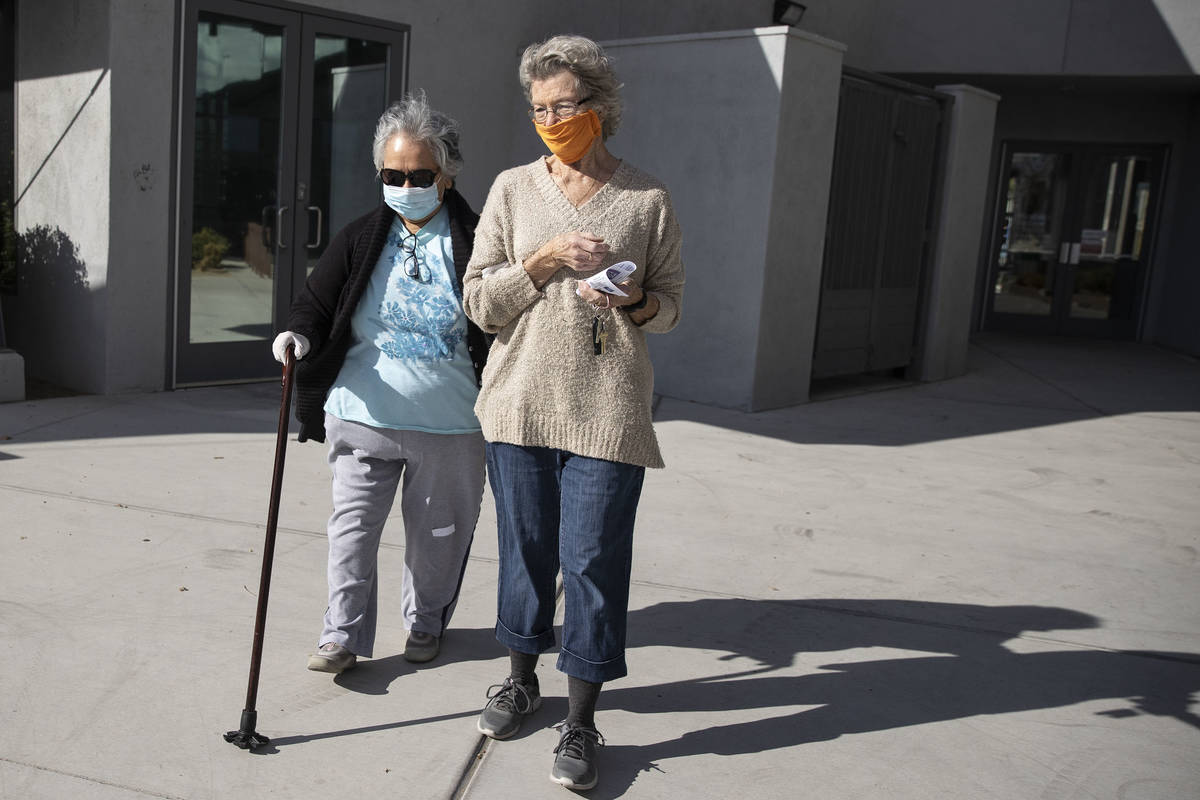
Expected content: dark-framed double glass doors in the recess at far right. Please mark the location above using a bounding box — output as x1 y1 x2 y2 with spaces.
985 143 1163 338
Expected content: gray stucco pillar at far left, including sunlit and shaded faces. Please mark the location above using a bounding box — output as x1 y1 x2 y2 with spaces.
5 0 175 393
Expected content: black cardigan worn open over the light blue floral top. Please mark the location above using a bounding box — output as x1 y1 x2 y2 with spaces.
288 188 490 441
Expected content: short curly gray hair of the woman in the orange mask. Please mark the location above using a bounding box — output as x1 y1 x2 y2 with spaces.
518 35 622 139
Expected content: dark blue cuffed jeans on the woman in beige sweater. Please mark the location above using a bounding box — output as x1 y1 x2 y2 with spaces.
487 441 646 684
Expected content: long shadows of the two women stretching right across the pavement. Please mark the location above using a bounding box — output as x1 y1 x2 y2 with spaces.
589 599 1200 798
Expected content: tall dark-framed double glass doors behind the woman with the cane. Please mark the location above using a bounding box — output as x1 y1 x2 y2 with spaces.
174 0 408 386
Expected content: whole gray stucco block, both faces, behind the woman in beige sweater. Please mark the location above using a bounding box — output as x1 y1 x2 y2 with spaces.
604 26 844 410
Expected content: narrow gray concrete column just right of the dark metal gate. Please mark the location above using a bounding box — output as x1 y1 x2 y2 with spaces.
916 85 1000 380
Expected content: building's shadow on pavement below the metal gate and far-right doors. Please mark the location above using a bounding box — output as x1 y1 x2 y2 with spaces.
654 333 1200 446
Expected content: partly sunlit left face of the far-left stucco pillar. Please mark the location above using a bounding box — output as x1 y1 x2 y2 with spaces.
5 0 112 392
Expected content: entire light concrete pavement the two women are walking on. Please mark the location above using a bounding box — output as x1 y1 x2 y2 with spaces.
0 336 1200 800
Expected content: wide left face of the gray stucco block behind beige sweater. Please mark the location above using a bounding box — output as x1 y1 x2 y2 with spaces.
605 30 784 408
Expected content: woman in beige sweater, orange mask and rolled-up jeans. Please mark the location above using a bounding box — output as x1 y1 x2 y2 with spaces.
463 36 684 789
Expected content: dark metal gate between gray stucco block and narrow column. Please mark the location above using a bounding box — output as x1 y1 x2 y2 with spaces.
812 70 952 378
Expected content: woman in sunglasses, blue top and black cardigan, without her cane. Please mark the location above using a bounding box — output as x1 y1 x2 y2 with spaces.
274 94 487 673
